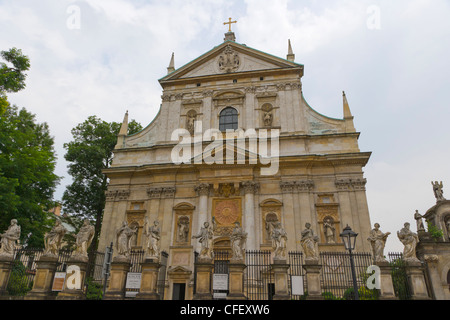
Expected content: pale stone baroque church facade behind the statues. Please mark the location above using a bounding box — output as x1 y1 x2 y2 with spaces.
99 31 371 298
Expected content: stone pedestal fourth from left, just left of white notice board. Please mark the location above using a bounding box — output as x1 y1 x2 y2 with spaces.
103 257 131 300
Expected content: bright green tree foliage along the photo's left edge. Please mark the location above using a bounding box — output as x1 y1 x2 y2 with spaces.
0 48 59 246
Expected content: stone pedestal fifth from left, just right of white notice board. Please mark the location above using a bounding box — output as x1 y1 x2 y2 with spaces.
135 259 161 300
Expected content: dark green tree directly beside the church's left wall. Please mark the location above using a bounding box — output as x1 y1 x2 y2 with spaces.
62 116 142 252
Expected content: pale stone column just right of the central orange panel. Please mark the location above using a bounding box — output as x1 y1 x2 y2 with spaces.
242 181 259 250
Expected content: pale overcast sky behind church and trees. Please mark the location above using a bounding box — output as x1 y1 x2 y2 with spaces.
0 0 450 251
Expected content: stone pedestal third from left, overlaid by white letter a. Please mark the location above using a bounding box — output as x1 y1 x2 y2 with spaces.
56 256 88 300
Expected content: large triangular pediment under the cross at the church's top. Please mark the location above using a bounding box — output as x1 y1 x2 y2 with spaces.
159 41 303 83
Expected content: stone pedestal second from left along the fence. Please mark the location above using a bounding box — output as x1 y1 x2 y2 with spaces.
24 255 59 300
